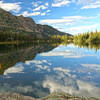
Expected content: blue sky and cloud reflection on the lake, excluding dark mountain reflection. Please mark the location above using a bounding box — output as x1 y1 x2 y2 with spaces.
0 44 100 97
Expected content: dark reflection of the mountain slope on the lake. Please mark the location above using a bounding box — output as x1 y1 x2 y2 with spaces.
0 43 54 74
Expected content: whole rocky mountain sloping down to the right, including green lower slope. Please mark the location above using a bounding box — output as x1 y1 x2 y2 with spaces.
0 8 70 40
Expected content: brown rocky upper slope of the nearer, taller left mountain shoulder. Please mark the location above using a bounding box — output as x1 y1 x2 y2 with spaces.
0 8 36 32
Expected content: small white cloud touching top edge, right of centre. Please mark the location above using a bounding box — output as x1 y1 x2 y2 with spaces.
52 0 70 7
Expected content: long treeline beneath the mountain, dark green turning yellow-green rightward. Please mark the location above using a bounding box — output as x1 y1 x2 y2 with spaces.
0 26 69 42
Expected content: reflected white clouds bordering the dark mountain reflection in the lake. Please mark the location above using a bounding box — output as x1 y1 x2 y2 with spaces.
4 59 52 78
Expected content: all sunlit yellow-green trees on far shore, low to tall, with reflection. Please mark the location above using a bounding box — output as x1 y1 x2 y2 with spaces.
49 30 100 51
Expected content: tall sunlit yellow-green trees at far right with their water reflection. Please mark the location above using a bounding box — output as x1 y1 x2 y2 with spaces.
73 30 100 51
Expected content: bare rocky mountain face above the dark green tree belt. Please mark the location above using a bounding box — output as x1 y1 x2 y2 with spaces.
0 8 70 38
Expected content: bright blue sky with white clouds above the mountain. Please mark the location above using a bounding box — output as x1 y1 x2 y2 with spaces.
0 0 100 35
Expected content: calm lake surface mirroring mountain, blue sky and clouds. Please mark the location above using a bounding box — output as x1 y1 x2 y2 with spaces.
0 43 100 98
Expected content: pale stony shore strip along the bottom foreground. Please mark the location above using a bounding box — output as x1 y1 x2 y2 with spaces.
0 93 100 100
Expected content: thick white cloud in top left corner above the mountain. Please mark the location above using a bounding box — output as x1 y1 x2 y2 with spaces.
0 1 21 13
